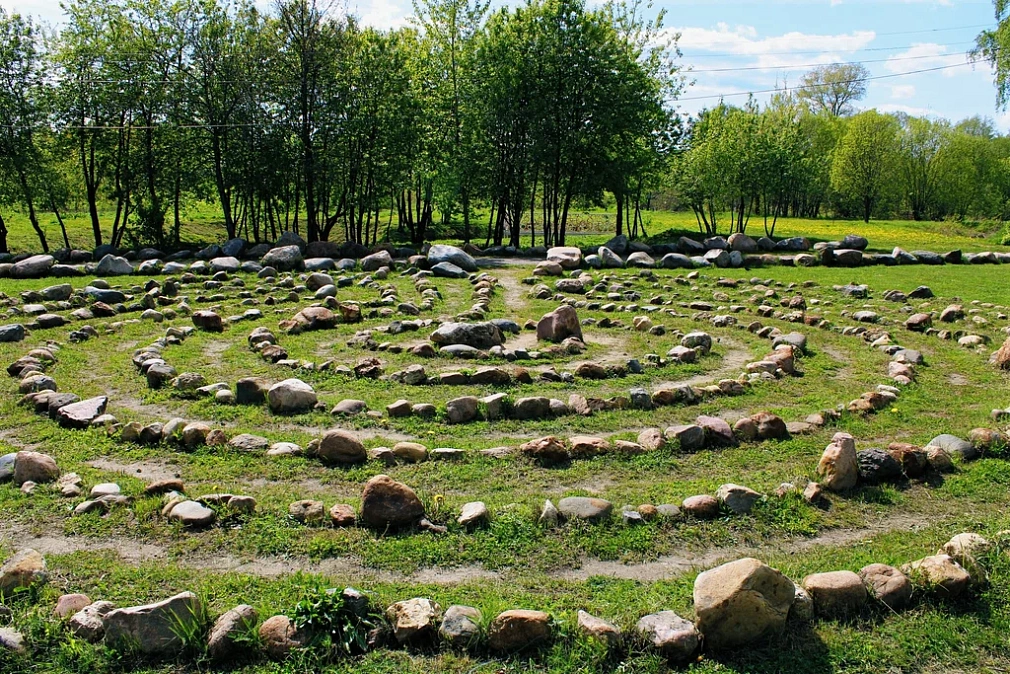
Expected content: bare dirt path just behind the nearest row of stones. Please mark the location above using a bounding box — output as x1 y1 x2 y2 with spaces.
0 515 935 585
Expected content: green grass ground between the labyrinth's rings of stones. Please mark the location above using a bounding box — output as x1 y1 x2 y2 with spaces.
0 250 1010 674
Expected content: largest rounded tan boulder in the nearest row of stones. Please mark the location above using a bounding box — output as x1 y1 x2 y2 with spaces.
694 558 796 650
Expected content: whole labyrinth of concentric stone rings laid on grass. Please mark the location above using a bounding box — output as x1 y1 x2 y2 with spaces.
0 236 1010 671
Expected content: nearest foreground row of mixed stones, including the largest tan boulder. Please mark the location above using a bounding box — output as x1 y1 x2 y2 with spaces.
0 534 990 665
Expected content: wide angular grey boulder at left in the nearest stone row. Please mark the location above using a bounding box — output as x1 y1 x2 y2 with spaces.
103 592 203 655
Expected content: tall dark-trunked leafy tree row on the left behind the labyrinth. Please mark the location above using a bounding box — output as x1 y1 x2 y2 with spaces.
0 0 683 250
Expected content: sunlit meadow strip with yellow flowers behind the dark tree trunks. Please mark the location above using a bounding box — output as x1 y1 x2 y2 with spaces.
5 202 1004 253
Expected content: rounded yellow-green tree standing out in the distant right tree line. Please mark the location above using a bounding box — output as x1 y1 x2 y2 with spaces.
831 110 898 222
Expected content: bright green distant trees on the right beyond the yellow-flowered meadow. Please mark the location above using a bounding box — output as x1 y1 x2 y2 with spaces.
665 86 1010 235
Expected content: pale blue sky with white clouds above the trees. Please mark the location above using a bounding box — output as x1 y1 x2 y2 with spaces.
0 0 1010 132
